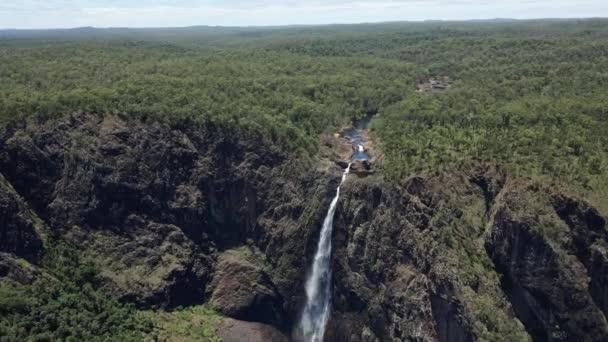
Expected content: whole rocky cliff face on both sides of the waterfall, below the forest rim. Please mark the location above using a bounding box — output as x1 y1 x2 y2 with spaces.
0 114 608 341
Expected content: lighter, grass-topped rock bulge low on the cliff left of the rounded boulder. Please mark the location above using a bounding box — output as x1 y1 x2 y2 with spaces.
65 219 213 307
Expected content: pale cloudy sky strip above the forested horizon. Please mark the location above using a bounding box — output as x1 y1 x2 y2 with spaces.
0 0 608 29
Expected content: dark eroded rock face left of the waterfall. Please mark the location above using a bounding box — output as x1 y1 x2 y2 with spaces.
0 114 339 329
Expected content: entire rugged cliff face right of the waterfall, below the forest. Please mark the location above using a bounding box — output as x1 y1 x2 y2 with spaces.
331 169 608 341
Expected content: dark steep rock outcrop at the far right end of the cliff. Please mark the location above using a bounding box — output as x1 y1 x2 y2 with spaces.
486 189 608 341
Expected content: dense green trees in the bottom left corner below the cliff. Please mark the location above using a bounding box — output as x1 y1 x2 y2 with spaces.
0 247 152 341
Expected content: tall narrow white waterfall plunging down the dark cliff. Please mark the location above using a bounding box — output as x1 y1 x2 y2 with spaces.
300 163 352 342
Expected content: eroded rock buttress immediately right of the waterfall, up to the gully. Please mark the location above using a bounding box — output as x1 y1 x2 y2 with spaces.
328 179 472 341
